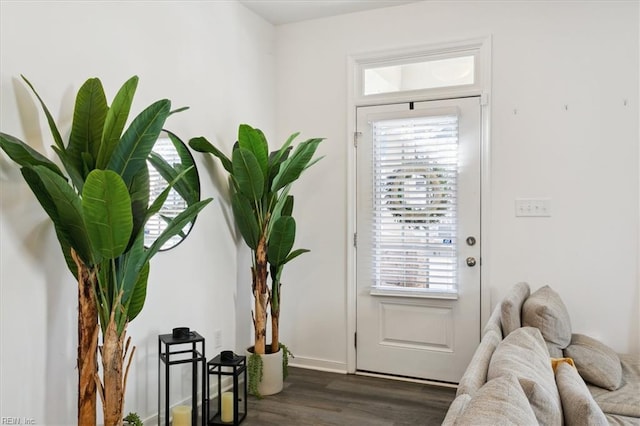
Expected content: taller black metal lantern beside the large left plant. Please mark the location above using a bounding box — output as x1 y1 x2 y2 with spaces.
158 327 207 426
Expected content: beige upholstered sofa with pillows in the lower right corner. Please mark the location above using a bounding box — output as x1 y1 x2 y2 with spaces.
443 283 640 426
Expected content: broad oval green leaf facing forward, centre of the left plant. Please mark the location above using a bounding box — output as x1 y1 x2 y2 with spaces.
82 170 133 259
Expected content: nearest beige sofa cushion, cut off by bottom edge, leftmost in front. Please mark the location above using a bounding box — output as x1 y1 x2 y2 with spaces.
455 374 537 426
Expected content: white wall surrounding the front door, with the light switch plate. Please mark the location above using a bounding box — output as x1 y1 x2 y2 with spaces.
276 1 640 370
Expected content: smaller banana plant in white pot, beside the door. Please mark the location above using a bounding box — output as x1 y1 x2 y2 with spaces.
189 124 323 396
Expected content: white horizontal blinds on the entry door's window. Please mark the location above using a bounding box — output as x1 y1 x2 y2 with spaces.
372 112 458 291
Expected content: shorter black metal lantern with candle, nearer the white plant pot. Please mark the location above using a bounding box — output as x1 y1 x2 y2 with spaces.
207 351 247 425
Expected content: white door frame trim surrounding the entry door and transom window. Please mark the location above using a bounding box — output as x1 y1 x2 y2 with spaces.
345 35 492 374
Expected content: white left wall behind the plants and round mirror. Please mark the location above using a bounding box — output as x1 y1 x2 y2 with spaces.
0 1 275 425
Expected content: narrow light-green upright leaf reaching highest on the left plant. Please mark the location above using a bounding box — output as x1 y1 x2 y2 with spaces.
96 76 138 169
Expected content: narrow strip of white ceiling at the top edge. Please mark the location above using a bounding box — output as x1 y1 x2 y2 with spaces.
239 0 422 25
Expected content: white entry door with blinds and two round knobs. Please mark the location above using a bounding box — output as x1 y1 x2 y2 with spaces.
356 97 481 383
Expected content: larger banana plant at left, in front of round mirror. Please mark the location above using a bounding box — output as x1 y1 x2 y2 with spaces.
0 76 211 426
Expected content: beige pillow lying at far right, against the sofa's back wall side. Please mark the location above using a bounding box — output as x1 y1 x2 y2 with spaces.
564 334 622 390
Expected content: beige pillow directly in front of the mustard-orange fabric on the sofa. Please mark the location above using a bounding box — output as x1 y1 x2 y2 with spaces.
556 362 608 426
